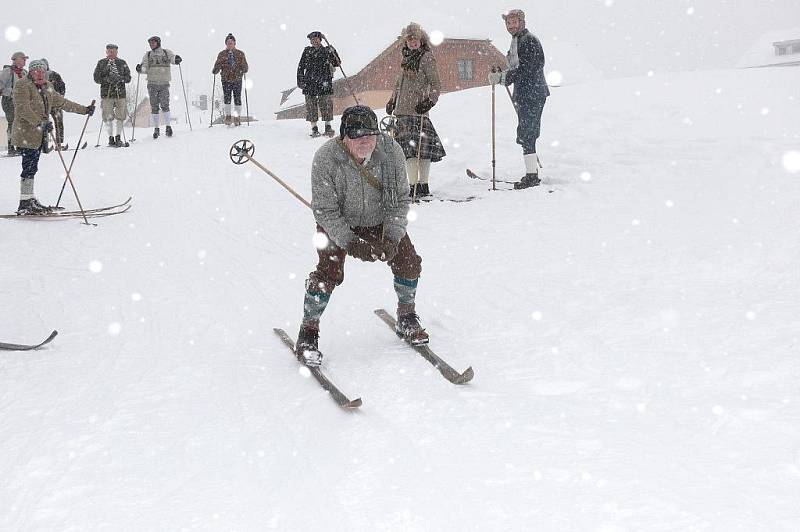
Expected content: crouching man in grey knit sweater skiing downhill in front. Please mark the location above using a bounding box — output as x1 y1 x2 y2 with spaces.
295 105 428 366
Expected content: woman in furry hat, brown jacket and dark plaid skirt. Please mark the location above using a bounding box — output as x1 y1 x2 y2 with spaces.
386 22 446 198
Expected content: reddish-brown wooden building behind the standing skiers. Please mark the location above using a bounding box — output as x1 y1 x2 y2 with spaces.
275 37 507 120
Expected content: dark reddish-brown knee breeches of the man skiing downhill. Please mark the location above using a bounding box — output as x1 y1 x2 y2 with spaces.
308 225 422 294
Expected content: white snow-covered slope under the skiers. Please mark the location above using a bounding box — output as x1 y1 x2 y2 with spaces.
0 69 800 531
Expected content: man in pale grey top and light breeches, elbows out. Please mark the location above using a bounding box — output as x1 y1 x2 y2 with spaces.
136 36 183 139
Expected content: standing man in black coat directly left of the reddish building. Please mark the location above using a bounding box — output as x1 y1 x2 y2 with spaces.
297 31 342 137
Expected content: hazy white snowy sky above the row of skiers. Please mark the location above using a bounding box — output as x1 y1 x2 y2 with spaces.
0 0 800 113
